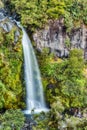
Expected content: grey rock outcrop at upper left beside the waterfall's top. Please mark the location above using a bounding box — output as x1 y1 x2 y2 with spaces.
0 8 20 44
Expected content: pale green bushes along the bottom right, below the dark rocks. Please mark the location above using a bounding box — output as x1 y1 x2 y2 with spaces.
33 97 87 130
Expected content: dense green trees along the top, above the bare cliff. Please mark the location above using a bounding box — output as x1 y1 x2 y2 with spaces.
4 0 87 31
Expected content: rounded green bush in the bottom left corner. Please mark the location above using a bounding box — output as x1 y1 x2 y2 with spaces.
0 109 25 130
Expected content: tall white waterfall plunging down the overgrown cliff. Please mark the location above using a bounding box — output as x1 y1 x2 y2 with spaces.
22 27 48 114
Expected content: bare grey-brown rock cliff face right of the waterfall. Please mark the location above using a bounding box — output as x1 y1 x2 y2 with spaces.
33 19 87 57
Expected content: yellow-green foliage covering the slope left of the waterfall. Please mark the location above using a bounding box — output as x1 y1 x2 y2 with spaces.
0 27 24 109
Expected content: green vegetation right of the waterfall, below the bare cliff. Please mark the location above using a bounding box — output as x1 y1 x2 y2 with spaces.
34 49 87 130
